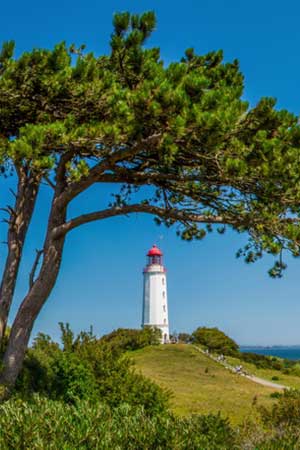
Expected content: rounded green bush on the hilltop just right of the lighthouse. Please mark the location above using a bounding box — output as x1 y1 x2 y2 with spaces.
192 327 239 356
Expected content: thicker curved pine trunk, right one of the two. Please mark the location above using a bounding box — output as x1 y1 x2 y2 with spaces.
0 200 65 390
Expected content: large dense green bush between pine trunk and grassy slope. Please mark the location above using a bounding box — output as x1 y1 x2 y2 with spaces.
16 324 170 414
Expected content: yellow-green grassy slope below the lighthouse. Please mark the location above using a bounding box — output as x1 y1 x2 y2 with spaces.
131 344 278 423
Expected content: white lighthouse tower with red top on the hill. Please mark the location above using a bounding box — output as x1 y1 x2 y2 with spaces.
142 245 169 344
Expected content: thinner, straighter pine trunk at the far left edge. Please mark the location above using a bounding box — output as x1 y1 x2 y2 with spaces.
0 172 39 342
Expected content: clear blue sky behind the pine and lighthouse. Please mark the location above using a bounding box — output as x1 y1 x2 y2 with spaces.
0 0 300 345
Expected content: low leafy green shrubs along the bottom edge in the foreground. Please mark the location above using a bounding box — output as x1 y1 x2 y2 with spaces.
0 396 235 450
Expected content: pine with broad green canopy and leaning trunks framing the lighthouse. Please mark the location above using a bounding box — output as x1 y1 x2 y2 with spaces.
0 12 300 384
